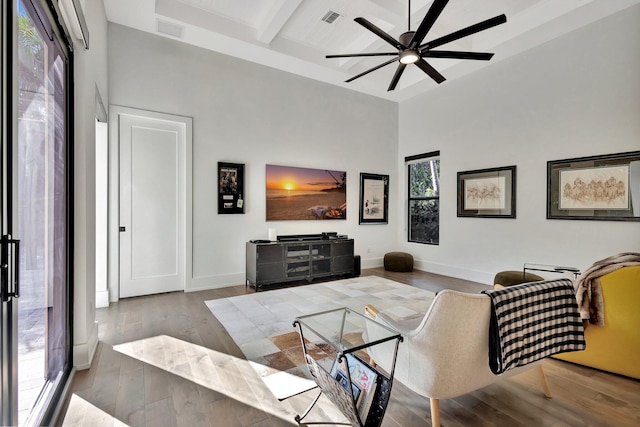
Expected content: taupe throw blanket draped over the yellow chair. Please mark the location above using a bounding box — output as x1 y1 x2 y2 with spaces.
574 252 640 326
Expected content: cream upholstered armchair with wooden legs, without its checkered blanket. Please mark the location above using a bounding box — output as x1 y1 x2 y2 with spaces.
365 290 551 426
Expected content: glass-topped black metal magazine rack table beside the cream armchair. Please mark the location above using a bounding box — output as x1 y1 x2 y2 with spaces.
293 308 402 427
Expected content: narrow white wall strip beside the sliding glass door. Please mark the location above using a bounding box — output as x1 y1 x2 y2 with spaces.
73 1 108 369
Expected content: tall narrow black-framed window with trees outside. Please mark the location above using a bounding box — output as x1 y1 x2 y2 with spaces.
404 151 440 245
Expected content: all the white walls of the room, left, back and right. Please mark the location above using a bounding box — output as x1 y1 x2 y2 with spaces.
74 1 640 367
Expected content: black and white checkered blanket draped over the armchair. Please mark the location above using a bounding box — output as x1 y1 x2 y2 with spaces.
483 279 585 375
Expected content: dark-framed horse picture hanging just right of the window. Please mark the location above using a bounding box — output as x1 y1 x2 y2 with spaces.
458 166 516 218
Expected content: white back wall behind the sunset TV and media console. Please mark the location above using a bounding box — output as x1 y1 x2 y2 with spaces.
109 23 399 290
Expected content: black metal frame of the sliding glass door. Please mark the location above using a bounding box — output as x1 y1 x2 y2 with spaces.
0 0 74 425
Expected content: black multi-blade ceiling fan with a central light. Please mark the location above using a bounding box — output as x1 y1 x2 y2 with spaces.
326 0 507 91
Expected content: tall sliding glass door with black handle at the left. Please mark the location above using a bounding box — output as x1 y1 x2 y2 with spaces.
0 0 71 425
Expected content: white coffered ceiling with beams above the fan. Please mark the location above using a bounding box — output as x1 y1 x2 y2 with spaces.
103 0 640 101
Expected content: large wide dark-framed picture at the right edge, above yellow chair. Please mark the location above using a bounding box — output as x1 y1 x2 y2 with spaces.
547 151 640 221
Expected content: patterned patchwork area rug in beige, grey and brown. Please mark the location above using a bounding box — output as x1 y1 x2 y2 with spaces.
205 276 435 398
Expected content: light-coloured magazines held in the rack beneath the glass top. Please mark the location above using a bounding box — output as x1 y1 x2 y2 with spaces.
330 354 378 424
